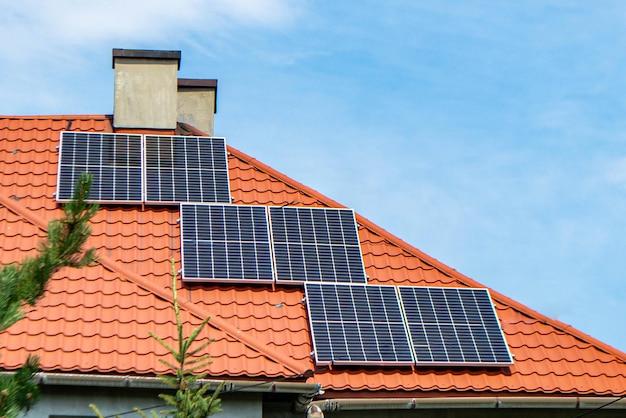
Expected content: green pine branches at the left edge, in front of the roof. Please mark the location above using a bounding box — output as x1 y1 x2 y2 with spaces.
0 173 98 418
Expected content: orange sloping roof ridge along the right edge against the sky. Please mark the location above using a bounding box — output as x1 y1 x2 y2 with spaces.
228 146 626 363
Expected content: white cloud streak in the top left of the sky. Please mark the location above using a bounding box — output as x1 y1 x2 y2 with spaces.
0 0 301 61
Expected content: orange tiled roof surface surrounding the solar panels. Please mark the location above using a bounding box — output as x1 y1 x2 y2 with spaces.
0 115 626 397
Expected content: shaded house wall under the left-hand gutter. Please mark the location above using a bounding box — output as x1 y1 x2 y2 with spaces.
26 386 263 418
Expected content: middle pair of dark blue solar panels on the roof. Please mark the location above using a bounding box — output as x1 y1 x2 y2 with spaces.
181 203 366 283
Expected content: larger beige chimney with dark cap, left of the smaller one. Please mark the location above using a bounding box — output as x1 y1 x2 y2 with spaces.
113 49 180 129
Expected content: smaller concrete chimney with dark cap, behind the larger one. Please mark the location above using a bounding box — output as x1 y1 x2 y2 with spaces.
177 78 217 136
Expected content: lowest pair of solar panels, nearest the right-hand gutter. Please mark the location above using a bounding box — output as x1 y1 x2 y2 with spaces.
305 283 513 366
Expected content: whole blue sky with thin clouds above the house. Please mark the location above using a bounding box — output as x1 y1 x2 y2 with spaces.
0 0 626 351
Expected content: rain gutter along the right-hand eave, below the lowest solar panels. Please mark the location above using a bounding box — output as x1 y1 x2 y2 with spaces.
307 396 626 417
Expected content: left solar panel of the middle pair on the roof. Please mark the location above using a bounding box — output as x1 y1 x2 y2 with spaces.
180 203 274 283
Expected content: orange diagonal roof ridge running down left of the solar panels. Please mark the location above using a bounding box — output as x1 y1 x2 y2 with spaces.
0 194 307 375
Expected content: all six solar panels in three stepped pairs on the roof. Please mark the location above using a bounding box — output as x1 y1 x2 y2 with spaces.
57 132 512 366
